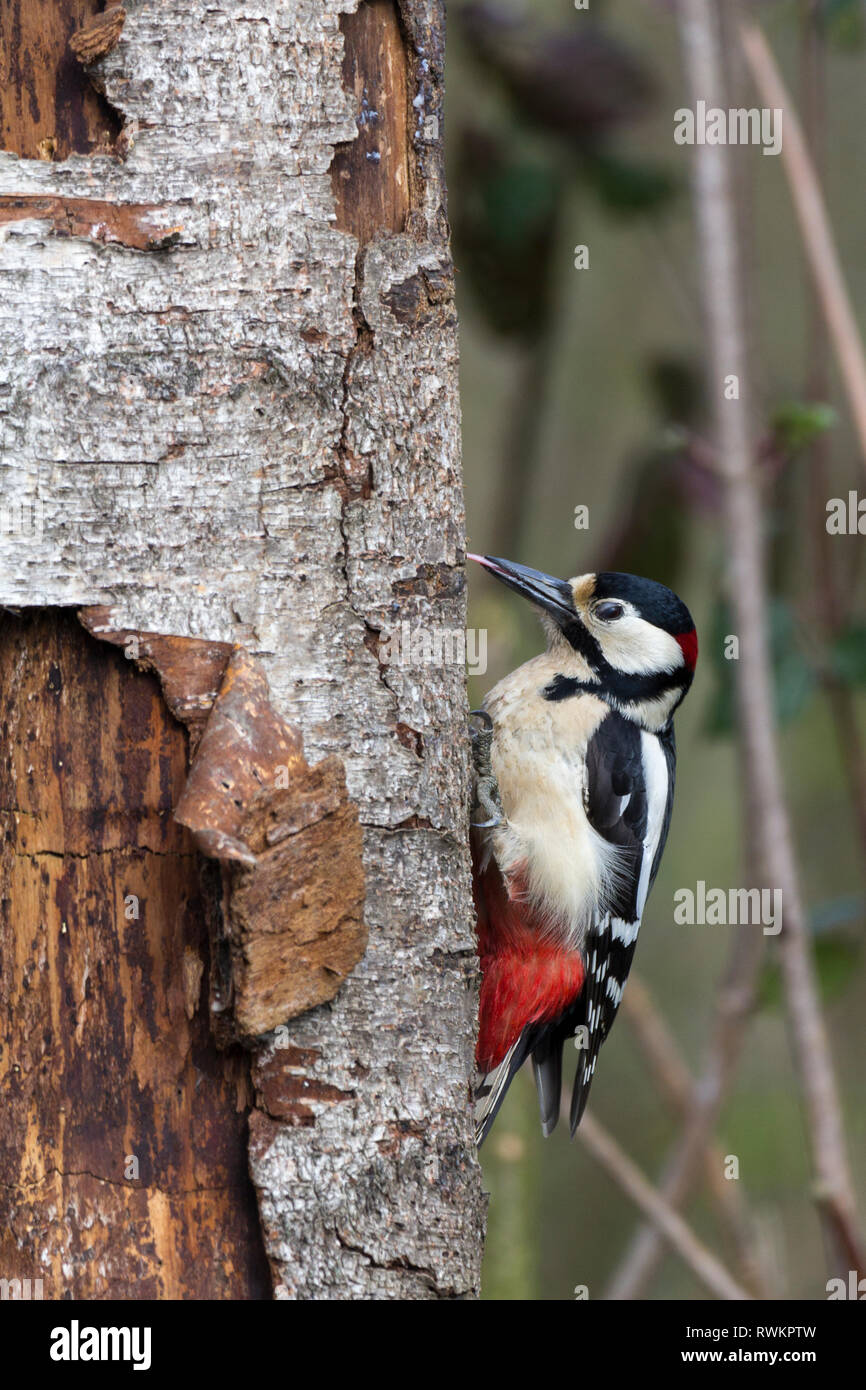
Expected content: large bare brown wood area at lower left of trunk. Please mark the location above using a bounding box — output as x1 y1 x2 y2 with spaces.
0 612 270 1298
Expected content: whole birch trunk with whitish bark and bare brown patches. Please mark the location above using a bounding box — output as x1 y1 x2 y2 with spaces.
0 0 484 1298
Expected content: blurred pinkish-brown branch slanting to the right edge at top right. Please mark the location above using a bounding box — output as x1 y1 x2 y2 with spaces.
740 22 866 478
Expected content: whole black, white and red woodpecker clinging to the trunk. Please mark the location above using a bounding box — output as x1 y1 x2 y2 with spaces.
468 555 698 1144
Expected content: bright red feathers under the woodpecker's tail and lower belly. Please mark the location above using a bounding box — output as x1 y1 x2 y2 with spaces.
474 839 585 1072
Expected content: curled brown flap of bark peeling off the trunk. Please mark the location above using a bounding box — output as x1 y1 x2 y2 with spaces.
79 622 367 1047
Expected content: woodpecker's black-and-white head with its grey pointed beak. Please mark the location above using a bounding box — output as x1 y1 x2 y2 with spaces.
468 555 698 728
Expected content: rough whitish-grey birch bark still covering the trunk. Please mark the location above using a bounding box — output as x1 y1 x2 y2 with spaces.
0 0 484 1298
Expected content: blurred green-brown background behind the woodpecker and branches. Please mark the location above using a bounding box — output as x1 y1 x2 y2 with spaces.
448 0 866 1300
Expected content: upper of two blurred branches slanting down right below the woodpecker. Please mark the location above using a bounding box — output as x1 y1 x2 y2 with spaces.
621 970 773 1298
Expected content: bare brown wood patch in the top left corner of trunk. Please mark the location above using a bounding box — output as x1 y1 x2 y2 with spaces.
0 0 122 160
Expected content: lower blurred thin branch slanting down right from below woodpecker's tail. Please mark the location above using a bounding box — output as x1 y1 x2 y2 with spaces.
577 1113 751 1301
